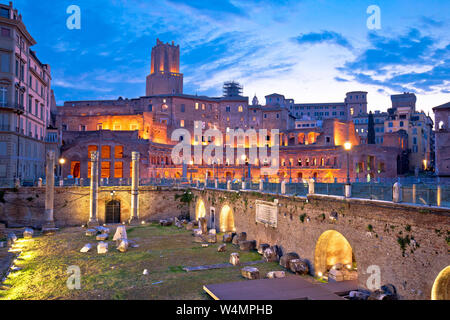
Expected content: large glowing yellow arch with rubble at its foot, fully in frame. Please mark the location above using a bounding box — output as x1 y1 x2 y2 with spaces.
314 230 356 276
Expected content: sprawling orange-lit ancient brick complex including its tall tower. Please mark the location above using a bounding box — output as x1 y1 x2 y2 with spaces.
56 40 401 182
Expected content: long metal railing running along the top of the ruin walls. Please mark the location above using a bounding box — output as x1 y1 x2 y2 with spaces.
0 177 450 208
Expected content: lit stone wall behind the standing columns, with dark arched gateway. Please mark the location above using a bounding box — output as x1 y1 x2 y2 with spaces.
0 187 186 228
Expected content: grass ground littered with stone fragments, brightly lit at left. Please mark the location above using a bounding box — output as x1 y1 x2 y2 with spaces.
0 224 283 300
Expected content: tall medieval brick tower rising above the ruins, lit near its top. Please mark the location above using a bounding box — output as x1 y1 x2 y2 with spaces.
146 39 183 96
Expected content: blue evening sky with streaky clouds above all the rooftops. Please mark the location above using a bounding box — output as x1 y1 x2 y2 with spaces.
7 0 450 112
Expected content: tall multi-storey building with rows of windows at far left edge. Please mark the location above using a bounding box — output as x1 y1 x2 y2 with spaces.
0 2 58 181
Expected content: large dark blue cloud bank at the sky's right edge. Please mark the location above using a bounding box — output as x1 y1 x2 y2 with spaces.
338 28 450 92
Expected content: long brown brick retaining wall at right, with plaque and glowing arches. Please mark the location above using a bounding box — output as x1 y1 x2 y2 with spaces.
191 190 450 299
